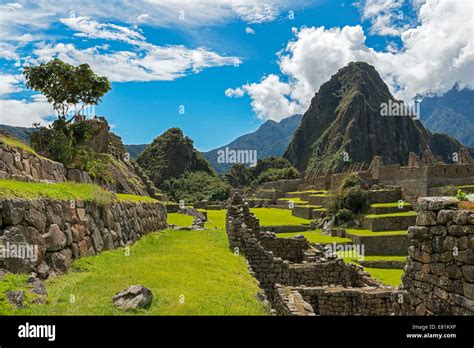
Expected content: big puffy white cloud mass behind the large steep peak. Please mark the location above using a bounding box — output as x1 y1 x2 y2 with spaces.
227 0 474 120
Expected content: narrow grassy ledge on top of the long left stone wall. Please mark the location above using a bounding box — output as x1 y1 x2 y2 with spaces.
0 179 156 203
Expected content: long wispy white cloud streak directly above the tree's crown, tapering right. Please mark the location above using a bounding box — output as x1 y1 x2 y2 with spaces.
32 42 241 82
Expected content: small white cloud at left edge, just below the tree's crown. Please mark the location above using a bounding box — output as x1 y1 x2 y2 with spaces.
0 94 54 127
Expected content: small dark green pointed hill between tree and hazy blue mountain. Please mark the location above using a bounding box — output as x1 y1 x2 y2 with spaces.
137 128 215 188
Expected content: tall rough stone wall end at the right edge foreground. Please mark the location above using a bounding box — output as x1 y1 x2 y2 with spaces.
402 197 474 315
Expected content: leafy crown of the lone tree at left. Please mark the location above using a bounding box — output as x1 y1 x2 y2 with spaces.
23 58 111 119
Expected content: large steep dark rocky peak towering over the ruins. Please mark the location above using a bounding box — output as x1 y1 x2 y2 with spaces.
284 62 461 171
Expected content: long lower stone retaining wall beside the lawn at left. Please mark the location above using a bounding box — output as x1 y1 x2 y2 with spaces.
0 198 167 278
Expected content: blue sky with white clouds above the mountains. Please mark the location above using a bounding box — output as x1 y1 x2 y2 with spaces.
0 0 474 151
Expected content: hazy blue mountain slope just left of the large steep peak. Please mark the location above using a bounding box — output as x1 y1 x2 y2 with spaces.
202 115 303 173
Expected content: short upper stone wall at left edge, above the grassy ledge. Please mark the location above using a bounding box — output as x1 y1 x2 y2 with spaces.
0 143 67 182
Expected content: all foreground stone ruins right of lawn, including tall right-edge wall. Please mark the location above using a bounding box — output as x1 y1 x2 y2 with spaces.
226 194 474 315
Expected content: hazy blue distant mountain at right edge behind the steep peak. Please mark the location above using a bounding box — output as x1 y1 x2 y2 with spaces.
420 85 474 147
